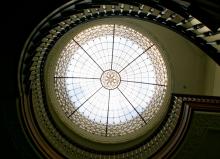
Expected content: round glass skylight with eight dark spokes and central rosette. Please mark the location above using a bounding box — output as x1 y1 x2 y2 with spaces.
54 24 168 137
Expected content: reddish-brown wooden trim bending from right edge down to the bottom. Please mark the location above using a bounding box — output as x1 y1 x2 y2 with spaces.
151 94 220 159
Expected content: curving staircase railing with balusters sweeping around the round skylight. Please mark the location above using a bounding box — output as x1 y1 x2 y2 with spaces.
19 0 220 159
